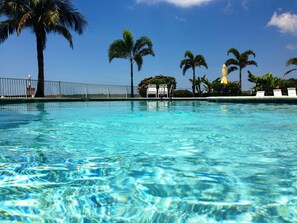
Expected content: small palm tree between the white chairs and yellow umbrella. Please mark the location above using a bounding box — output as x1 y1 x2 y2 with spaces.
179 51 208 96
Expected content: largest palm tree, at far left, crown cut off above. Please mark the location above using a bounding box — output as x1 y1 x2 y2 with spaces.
0 0 87 97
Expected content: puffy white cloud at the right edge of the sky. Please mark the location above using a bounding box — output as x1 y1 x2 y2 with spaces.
267 12 297 35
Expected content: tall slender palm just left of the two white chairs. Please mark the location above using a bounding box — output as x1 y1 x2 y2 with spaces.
108 30 155 97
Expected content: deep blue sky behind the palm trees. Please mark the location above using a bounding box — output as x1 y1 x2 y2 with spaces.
0 0 297 89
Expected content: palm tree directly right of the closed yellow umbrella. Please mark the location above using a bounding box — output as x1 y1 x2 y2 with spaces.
225 48 258 90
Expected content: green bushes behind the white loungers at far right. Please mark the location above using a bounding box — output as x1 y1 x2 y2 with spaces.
248 71 297 95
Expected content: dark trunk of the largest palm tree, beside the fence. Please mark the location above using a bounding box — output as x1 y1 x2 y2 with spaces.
35 36 44 97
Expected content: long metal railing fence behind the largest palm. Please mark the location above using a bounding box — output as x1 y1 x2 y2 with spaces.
0 77 138 98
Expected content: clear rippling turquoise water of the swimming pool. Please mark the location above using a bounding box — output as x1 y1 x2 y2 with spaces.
0 101 297 223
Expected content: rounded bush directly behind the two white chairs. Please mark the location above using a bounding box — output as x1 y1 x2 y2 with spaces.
138 75 176 97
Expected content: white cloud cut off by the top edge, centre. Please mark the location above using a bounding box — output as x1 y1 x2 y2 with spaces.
136 0 215 8
